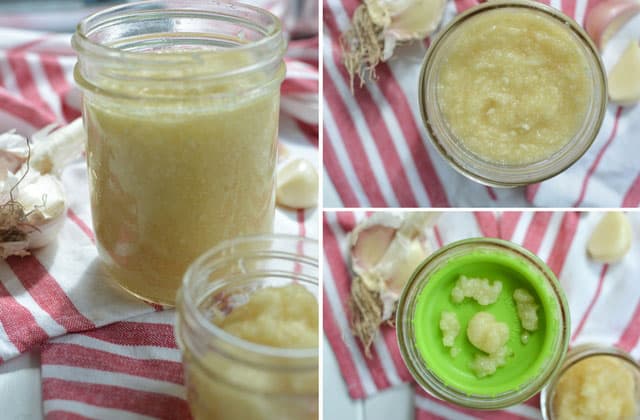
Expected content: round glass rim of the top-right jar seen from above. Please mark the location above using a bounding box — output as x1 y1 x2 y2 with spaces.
418 0 608 187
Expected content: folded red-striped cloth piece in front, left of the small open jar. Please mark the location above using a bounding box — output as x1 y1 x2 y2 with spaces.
41 310 191 420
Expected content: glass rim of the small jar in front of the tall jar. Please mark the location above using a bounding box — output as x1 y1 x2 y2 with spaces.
176 234 319 360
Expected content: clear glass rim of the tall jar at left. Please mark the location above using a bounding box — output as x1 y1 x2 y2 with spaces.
71 0 285 66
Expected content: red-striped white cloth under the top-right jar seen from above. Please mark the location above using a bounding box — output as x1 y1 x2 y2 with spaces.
323 0 640 207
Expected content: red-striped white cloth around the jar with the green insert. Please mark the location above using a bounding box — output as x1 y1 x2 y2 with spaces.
323 212 640 419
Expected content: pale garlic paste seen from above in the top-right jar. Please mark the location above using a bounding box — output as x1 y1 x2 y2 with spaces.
437 8 593 165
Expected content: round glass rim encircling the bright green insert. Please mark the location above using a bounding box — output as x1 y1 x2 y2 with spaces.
396 237 570 409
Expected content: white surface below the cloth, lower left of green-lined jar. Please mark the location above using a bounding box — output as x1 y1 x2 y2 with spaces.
322 337 414 420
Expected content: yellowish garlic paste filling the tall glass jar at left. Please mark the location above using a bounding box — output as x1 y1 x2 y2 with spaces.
84 46 283 304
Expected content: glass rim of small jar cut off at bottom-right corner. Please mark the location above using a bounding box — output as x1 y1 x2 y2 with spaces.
540 343 640 420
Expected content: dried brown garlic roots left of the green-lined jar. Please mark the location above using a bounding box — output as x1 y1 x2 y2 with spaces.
349 277 383 358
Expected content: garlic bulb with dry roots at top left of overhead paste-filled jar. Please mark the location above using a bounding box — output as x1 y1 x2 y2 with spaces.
340 0 446 89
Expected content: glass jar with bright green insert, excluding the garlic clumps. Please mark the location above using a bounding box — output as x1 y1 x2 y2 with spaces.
396 238 570 409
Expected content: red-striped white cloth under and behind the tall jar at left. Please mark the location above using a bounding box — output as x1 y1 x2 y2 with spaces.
0 29 318 368
